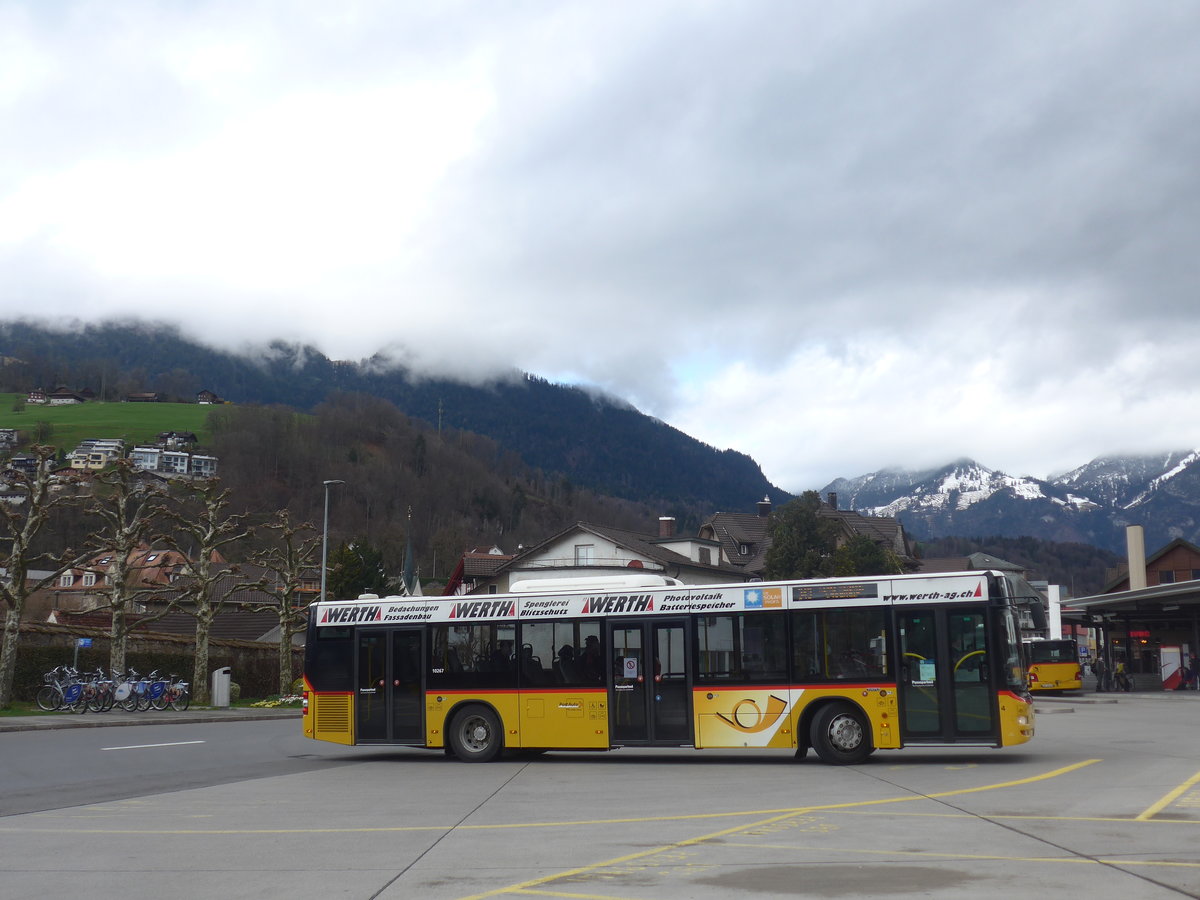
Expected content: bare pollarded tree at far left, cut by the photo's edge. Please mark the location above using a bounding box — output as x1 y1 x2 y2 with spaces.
0 446 83 709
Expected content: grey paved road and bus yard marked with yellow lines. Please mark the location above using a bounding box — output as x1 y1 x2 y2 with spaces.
0 695 1200 900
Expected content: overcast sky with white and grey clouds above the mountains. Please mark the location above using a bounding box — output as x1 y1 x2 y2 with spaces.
0 0 1200 491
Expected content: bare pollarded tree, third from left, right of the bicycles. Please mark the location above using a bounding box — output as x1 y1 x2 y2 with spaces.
166 478 252 706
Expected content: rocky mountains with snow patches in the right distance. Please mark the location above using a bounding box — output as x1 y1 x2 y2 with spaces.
823 450 1200 552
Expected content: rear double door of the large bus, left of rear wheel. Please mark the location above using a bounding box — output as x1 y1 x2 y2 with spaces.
354 628 425 746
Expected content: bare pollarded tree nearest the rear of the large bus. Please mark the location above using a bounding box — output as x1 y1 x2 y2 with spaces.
246 509 320 695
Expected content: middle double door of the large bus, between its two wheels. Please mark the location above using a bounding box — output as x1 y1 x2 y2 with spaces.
608 619 692 746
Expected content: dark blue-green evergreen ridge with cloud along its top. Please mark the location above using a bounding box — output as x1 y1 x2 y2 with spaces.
0 322 791 511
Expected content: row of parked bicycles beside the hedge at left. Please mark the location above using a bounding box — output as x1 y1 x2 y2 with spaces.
37 666 192 713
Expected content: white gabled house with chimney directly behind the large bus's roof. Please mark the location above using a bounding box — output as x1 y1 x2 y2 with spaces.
472 520 748 594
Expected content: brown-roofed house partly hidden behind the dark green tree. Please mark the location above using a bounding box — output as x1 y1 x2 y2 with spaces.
700 493 912 577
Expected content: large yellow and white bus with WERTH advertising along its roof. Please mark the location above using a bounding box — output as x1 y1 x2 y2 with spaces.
304 571 1034 764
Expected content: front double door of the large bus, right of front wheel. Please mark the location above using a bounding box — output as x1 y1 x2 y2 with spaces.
896 606 998 743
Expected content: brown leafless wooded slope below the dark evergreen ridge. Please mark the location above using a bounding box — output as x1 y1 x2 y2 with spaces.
21 394 667 580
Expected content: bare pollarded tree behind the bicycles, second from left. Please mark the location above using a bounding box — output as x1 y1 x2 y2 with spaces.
88 460 175 672
